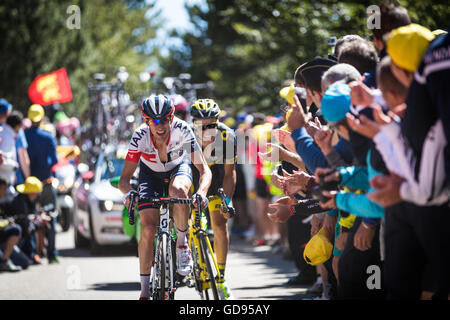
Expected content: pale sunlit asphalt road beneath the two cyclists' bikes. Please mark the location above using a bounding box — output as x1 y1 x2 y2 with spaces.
0 225 312 300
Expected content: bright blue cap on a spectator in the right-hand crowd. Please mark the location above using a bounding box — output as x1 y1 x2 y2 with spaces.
321 82 352 122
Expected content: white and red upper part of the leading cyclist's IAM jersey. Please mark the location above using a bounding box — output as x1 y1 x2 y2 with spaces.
126 117 200 172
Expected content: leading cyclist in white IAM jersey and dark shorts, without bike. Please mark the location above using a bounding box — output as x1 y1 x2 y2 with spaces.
119 95 212 300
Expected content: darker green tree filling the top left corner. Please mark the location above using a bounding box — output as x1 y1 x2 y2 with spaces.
0 0 86 111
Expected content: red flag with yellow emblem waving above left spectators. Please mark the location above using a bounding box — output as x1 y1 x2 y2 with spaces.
28 68 72 106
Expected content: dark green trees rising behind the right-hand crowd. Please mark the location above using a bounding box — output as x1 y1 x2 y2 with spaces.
161 0 450 113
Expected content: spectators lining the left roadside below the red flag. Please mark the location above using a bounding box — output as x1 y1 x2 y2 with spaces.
0 102 78 272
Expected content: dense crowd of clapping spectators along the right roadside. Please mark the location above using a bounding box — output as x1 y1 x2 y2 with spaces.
225 2 450 300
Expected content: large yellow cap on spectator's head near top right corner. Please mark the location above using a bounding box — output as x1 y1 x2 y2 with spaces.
386 23 435 72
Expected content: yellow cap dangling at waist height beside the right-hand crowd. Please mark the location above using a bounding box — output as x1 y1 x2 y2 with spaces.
303 228 333 266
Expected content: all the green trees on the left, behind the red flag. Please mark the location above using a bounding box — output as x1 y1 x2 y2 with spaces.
0 0 160 115
